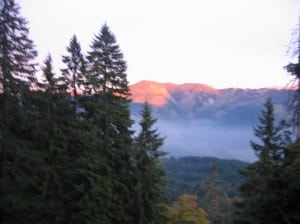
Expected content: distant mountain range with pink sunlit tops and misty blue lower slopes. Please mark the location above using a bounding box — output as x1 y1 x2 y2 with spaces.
130 81 293 161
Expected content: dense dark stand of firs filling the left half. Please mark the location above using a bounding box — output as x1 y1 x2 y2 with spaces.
0 0 165 224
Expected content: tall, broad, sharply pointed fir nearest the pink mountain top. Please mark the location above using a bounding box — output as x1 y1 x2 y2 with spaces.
85 24 134 223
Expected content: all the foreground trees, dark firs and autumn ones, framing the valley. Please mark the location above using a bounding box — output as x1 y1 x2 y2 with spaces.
0 0 300 224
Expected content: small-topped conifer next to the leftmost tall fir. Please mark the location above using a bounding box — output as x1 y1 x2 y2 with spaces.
33 54 69 223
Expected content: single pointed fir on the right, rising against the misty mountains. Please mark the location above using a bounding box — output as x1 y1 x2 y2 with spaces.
237 99 291 223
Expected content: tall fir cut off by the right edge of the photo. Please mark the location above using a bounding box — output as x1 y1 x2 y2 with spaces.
281 16 300 223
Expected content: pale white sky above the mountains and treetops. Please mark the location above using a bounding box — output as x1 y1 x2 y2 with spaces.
16 0 300 88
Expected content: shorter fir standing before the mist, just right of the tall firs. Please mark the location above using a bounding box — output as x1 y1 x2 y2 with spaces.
133 103 166 224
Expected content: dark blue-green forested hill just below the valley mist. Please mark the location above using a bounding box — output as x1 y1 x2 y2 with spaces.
161 157 248 202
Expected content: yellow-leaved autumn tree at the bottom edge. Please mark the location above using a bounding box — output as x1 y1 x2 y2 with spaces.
167 194 210 224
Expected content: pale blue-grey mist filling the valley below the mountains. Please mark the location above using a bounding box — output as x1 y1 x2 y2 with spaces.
133 117 256 162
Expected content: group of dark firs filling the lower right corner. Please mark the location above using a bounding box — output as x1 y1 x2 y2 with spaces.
235 99 300 224
